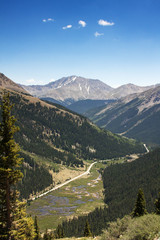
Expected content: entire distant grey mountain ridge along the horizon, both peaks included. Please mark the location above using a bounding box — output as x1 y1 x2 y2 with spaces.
22 76 154 106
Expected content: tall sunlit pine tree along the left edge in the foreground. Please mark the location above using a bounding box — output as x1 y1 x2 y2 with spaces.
0 92 34 240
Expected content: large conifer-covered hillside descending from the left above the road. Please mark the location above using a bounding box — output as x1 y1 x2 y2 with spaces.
0 90 144 163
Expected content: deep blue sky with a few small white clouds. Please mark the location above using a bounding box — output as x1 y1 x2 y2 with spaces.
0 0 160 87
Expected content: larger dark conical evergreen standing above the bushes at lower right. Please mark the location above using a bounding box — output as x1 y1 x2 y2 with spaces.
132 188 147 217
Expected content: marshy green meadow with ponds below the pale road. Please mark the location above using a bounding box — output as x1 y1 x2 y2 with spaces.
27 163 104 231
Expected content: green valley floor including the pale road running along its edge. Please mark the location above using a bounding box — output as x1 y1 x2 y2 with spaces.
27 152 144 231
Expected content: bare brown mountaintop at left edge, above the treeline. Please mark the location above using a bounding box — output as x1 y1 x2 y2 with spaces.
0 73 29 94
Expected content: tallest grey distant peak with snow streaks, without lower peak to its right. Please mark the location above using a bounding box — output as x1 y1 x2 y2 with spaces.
23 76 112 105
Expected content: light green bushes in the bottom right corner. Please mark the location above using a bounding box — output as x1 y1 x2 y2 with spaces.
101 214 160 240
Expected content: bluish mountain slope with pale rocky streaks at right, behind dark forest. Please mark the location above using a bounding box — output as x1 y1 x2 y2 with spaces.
86 86 160 146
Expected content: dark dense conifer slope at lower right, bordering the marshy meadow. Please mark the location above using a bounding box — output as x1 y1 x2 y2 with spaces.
57 148 160 237
